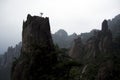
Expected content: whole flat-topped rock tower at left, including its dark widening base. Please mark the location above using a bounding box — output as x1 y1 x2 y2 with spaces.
12 15 57 80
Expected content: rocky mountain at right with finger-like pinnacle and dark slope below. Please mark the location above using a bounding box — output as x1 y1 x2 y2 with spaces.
69 20 120 80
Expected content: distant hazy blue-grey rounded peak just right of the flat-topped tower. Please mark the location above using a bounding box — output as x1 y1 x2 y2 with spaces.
52 29 77 48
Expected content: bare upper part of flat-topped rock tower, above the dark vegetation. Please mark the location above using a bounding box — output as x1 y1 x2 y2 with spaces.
22 14 53 53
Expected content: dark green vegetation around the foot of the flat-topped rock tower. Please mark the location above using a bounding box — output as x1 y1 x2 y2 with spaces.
12 45 81 80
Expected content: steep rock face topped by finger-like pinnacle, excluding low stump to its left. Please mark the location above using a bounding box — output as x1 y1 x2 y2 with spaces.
85 20 112 58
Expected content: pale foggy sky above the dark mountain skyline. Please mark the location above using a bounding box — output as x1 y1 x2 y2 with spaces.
0 0 120 53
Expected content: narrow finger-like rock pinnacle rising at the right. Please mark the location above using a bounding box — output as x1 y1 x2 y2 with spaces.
99 20 112 53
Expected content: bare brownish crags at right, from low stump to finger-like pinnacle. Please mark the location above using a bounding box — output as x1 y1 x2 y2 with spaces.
70 20 112 60
